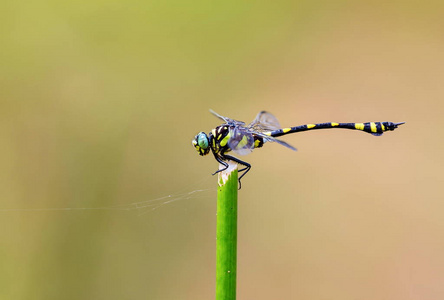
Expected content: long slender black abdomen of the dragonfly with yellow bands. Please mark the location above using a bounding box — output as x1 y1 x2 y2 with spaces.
267 122 404 137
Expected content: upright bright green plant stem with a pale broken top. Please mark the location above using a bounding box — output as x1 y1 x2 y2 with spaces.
216 164 238 300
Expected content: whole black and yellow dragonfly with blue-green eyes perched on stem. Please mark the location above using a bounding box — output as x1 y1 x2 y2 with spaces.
192 109 405 189
